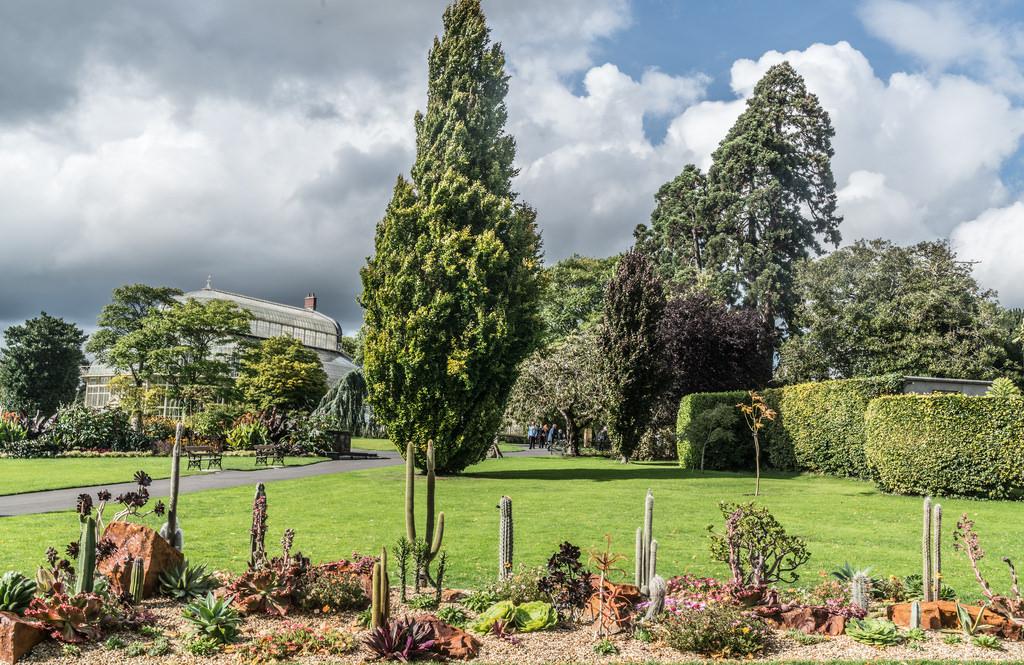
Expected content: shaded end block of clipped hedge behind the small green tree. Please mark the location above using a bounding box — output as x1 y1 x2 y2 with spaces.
676 390 754 470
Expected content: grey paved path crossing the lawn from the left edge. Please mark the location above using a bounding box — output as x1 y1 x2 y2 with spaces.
0 449 547 517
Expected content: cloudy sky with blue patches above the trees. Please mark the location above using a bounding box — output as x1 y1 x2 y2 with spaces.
0 0 1024 332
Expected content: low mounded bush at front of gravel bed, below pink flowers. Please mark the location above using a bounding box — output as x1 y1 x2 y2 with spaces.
660 602 772 659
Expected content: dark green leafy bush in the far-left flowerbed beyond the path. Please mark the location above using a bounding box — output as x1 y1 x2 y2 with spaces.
45 404 150 452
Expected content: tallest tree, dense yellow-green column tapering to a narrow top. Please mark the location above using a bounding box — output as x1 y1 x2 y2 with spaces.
361 0 542 472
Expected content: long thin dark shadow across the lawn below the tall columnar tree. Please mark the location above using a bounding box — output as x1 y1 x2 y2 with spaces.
462 457 801 483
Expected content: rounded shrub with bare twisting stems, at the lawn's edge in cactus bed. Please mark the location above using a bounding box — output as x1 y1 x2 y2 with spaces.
708 501 811 587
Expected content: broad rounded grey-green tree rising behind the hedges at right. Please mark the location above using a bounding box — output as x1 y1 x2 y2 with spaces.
778 240 1007 382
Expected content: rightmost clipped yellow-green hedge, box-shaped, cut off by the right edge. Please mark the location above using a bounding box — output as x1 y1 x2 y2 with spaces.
865 394 1024 499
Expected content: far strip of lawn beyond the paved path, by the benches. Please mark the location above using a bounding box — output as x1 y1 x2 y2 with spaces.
0 457 325 495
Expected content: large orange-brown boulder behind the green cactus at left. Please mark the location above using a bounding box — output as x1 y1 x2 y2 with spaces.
96 522 184 598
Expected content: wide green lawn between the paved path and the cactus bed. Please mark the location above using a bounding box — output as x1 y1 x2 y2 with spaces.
0 456 1024 598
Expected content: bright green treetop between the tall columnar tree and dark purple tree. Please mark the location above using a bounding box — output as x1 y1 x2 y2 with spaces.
541 254 618 342
